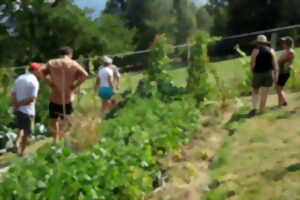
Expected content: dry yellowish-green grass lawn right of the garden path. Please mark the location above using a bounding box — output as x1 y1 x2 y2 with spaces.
210 93 300 200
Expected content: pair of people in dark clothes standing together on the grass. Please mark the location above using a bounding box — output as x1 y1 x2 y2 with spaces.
249 35 295 117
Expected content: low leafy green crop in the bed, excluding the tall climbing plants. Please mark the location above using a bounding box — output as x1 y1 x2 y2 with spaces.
0 96 199 200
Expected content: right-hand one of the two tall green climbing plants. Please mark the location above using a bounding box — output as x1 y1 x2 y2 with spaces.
187 31 217 103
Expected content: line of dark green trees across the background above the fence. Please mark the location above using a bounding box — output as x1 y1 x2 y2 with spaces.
0 0 300 66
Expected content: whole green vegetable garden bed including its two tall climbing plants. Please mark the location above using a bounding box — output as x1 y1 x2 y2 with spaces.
0 32 300 200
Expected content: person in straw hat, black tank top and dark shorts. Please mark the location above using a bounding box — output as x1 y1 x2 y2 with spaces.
249 35 278 117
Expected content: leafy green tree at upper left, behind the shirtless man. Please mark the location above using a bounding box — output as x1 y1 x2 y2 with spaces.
0 0 136 65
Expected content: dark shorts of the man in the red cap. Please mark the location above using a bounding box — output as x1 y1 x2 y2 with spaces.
16 112 34 135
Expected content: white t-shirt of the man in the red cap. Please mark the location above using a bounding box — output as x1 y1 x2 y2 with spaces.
12 73 40 116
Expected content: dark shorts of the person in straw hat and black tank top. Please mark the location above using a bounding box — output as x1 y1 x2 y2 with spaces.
252 71 274 89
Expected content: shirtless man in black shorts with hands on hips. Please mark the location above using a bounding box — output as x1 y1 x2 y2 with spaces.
41 47 88 142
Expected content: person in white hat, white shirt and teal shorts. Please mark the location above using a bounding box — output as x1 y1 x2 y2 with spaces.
95 56 120 117
